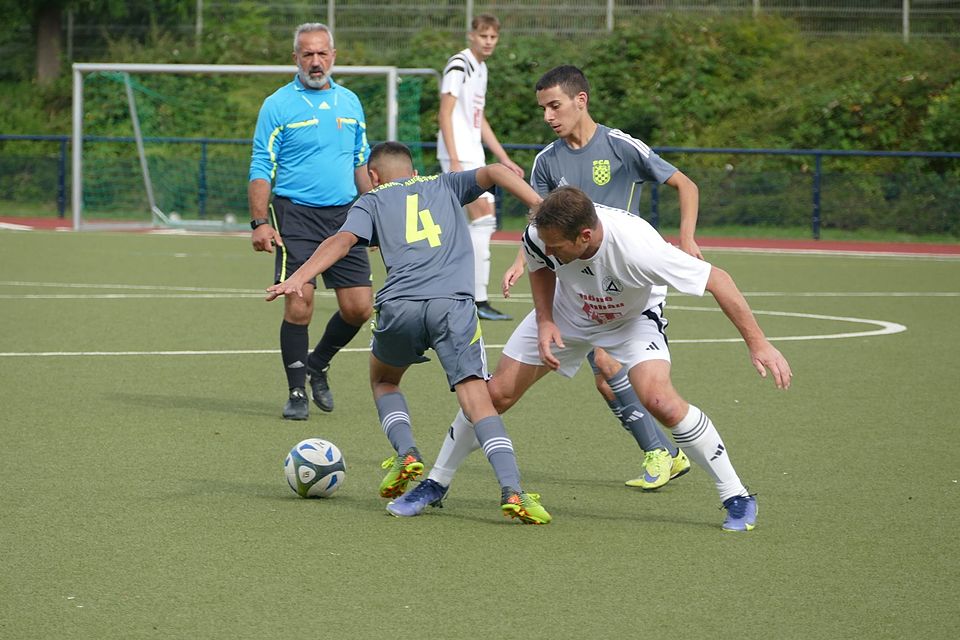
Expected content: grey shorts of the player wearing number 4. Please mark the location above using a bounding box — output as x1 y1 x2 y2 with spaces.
373 298 490 390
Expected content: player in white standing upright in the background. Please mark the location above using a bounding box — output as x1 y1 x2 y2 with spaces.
437 14 523 320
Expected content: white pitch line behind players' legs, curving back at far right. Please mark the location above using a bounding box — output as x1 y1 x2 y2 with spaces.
0 305 907 358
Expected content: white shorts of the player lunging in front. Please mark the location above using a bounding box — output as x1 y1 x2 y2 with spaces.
503 306 670 378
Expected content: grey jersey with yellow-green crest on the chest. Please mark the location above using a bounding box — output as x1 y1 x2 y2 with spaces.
530 124 677 214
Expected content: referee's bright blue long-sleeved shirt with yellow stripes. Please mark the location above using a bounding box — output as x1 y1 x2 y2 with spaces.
250 77 370 207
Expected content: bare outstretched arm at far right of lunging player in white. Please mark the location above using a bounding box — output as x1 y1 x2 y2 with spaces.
707 267 793 389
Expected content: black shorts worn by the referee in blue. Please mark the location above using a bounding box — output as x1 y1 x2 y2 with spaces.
270 196 373 289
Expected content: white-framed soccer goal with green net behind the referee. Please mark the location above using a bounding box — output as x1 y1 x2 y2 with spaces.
71 63 437 231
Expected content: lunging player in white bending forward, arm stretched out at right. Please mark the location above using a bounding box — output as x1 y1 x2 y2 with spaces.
394 187 793 531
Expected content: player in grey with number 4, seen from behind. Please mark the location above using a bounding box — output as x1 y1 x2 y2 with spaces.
267 142 551 524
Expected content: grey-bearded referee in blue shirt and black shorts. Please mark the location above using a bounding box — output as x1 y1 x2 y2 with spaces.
247 23 373 420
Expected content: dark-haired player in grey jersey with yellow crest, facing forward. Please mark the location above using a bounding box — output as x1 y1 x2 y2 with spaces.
430 65 703 491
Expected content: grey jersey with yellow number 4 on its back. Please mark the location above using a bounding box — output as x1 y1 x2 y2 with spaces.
340 170 484 307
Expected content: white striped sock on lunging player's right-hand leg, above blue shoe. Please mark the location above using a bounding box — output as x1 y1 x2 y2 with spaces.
670 405 747 502
